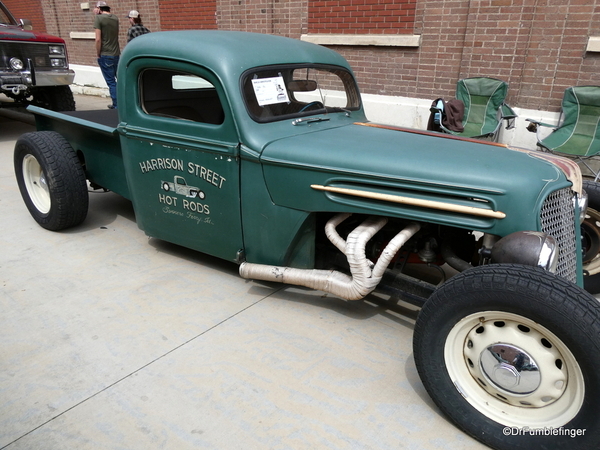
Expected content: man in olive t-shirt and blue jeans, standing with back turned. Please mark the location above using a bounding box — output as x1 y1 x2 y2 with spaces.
94 1 121 109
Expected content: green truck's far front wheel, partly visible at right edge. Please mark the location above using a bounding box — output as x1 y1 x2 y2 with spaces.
581 180 600 294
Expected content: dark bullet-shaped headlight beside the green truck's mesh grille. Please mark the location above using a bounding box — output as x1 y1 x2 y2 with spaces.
492 231 558 273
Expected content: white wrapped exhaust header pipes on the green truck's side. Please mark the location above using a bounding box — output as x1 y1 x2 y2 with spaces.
240 214 421 300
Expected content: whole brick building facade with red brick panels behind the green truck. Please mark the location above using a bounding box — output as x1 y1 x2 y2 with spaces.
5 0 600 111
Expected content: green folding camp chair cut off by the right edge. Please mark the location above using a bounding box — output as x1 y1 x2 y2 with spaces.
526 86 600 181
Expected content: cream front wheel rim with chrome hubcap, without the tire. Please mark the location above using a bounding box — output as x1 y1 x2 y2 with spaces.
444 311 585 428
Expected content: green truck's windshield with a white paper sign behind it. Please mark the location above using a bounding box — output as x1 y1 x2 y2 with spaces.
242 65 360 122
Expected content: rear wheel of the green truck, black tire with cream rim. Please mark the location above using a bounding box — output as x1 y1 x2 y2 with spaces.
14 131 89 231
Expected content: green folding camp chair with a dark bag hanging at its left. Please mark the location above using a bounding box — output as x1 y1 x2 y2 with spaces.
432 77 517 141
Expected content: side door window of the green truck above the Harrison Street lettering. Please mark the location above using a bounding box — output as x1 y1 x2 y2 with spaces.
140 69 225 125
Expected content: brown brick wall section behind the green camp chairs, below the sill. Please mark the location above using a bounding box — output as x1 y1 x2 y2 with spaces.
335 0 600 111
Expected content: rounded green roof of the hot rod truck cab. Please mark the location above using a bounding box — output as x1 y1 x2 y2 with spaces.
121 30 350 83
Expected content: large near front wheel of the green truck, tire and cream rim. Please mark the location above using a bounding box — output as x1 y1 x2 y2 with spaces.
413 265 600 450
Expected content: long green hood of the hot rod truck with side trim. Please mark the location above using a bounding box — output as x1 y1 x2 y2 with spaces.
261 123 580 235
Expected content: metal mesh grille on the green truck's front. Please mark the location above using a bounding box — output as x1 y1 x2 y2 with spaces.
540 188 577 283
